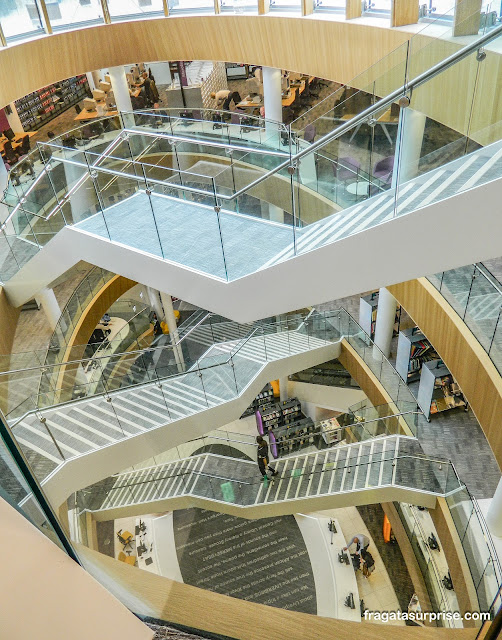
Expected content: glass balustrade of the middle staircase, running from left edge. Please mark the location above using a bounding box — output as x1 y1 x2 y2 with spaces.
0 310 428 488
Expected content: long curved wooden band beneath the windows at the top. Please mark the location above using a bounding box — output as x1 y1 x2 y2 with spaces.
0 14 502 144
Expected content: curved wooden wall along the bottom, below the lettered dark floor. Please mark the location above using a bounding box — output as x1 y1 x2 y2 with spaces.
76 545 477 640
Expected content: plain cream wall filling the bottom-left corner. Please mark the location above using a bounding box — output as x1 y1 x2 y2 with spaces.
0 498 153 640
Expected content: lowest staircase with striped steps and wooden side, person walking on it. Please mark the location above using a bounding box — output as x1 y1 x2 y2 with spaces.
81 436 452 520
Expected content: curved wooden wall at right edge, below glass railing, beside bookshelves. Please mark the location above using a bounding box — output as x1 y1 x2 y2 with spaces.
388 278 502 467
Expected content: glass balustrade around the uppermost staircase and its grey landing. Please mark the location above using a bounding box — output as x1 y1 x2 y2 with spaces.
0 21 500 281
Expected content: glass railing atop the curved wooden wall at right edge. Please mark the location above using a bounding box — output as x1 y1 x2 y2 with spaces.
428 263 502 374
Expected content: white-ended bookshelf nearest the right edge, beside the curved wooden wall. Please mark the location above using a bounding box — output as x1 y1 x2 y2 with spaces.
417 360 467 420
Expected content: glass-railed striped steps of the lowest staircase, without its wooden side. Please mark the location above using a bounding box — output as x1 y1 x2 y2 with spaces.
76 438 459 511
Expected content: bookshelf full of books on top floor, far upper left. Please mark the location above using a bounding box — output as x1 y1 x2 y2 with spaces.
14 75 90 131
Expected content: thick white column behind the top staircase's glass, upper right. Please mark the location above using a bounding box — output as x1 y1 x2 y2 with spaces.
392 107 426 188
